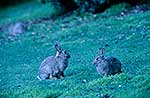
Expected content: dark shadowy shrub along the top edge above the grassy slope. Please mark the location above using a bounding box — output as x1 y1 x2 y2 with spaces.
41 0 150 13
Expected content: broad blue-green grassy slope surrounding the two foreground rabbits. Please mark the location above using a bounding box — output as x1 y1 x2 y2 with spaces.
0 2 150 98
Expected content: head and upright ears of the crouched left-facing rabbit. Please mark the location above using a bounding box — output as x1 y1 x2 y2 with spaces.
92 48 105 66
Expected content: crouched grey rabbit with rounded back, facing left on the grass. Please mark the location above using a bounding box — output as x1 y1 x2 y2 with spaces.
93 48 121 76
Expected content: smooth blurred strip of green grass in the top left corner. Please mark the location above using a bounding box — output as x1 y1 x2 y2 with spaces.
0 0 59 25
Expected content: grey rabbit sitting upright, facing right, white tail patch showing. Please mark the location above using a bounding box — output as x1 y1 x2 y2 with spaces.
37 43 70 80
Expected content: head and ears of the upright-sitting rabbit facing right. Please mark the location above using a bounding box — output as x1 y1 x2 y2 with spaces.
55 43 70 59
